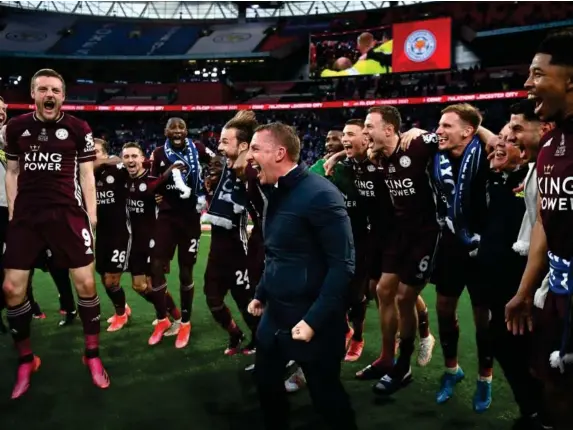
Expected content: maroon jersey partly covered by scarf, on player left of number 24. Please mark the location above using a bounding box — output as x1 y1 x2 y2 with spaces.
151 141 214 216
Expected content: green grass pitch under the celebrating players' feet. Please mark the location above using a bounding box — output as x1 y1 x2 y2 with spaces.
0 234 517 430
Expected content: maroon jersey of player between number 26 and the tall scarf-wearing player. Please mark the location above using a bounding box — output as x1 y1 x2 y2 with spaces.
125 170 157 247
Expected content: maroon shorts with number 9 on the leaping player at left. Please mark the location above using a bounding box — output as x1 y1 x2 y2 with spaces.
4 206 94 270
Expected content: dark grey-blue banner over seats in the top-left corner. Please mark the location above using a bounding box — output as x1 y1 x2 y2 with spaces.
0 14 76 53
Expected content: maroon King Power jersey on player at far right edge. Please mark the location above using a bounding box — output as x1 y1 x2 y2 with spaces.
537 125 573 260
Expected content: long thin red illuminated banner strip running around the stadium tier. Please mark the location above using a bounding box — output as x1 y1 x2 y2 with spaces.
8 90 527 112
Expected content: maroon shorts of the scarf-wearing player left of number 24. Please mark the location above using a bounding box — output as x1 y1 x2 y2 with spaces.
150 211 201 267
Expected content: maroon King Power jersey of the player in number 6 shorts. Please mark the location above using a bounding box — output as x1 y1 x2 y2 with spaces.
380 134 438 228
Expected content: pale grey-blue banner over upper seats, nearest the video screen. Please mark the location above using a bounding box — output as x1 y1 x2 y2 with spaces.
187 24 269 58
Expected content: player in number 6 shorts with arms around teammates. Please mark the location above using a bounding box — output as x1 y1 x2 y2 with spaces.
365 106 440 394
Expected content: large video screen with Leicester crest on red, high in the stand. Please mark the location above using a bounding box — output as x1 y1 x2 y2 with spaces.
310 18 452 79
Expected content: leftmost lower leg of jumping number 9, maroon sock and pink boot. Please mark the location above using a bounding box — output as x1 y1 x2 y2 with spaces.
3 269 40 399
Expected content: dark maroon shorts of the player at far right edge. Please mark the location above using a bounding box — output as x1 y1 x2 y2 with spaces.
532 291 573 382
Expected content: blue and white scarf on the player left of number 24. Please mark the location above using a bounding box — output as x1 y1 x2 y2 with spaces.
164 139 206 212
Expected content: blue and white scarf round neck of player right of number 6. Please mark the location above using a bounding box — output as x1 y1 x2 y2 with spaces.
434 136 483 255
